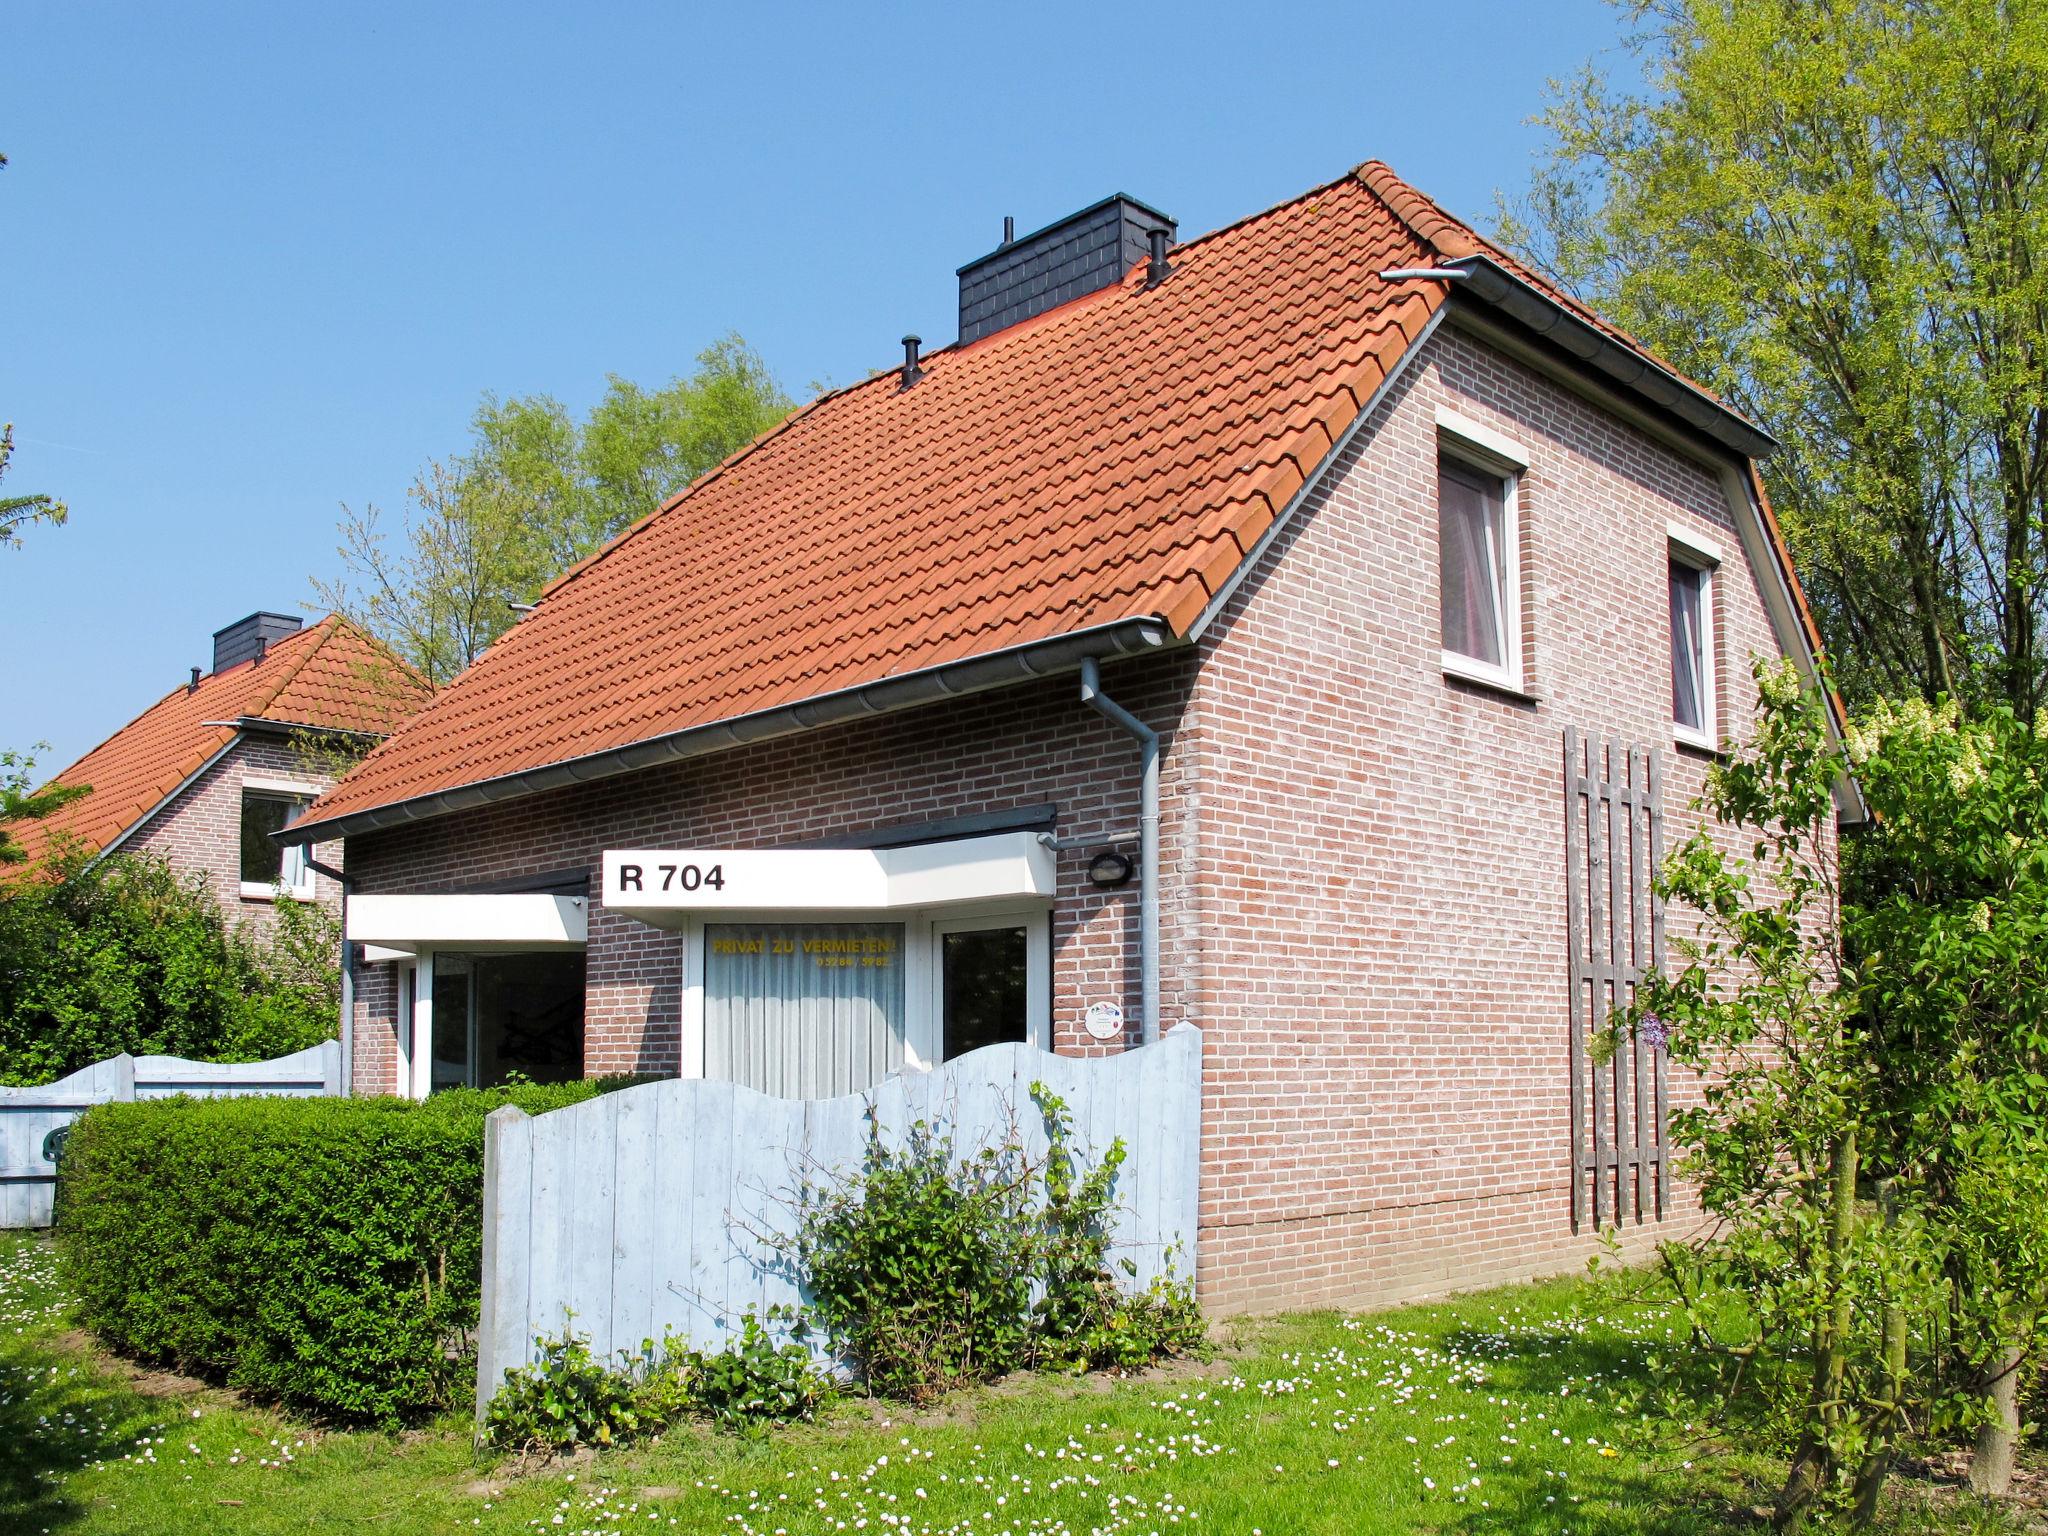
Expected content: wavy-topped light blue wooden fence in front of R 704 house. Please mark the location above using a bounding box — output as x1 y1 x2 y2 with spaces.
477 1026 1202 1415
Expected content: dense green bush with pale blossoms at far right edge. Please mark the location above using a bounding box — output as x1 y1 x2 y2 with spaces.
1845 700 2048 1495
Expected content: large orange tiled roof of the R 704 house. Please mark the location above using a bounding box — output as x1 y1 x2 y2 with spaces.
301 162 1826 836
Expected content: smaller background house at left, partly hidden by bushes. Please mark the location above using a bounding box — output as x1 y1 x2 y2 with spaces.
8 612 428 928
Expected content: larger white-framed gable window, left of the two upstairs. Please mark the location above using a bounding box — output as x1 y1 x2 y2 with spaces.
1436 410 1528 692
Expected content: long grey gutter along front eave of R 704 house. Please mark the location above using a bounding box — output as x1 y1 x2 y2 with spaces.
290 616 1180 846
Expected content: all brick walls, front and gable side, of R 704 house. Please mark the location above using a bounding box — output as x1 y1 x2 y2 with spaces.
339 319 1843 1311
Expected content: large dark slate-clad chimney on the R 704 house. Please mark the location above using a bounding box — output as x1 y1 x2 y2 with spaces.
961 193 1176 342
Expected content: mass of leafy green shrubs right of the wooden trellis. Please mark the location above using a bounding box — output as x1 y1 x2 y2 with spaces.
1616 666 2048 1526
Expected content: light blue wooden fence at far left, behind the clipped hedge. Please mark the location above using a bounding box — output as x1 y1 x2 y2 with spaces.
0 1040 342 1227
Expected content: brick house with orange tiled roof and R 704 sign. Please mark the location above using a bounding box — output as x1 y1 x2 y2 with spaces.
287 164 1853 1309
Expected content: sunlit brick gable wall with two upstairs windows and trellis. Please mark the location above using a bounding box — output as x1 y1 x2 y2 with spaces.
1184 330 1826 1309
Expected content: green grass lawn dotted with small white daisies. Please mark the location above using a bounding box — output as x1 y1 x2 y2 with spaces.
0 1233 2019 1536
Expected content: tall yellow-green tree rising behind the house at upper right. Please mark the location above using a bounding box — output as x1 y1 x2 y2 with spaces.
1505 0 2048 719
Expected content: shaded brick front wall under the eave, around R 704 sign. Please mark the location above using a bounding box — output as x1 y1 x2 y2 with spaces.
348 651 1196 1090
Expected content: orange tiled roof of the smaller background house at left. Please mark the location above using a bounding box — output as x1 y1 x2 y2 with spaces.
8 614 430 860
